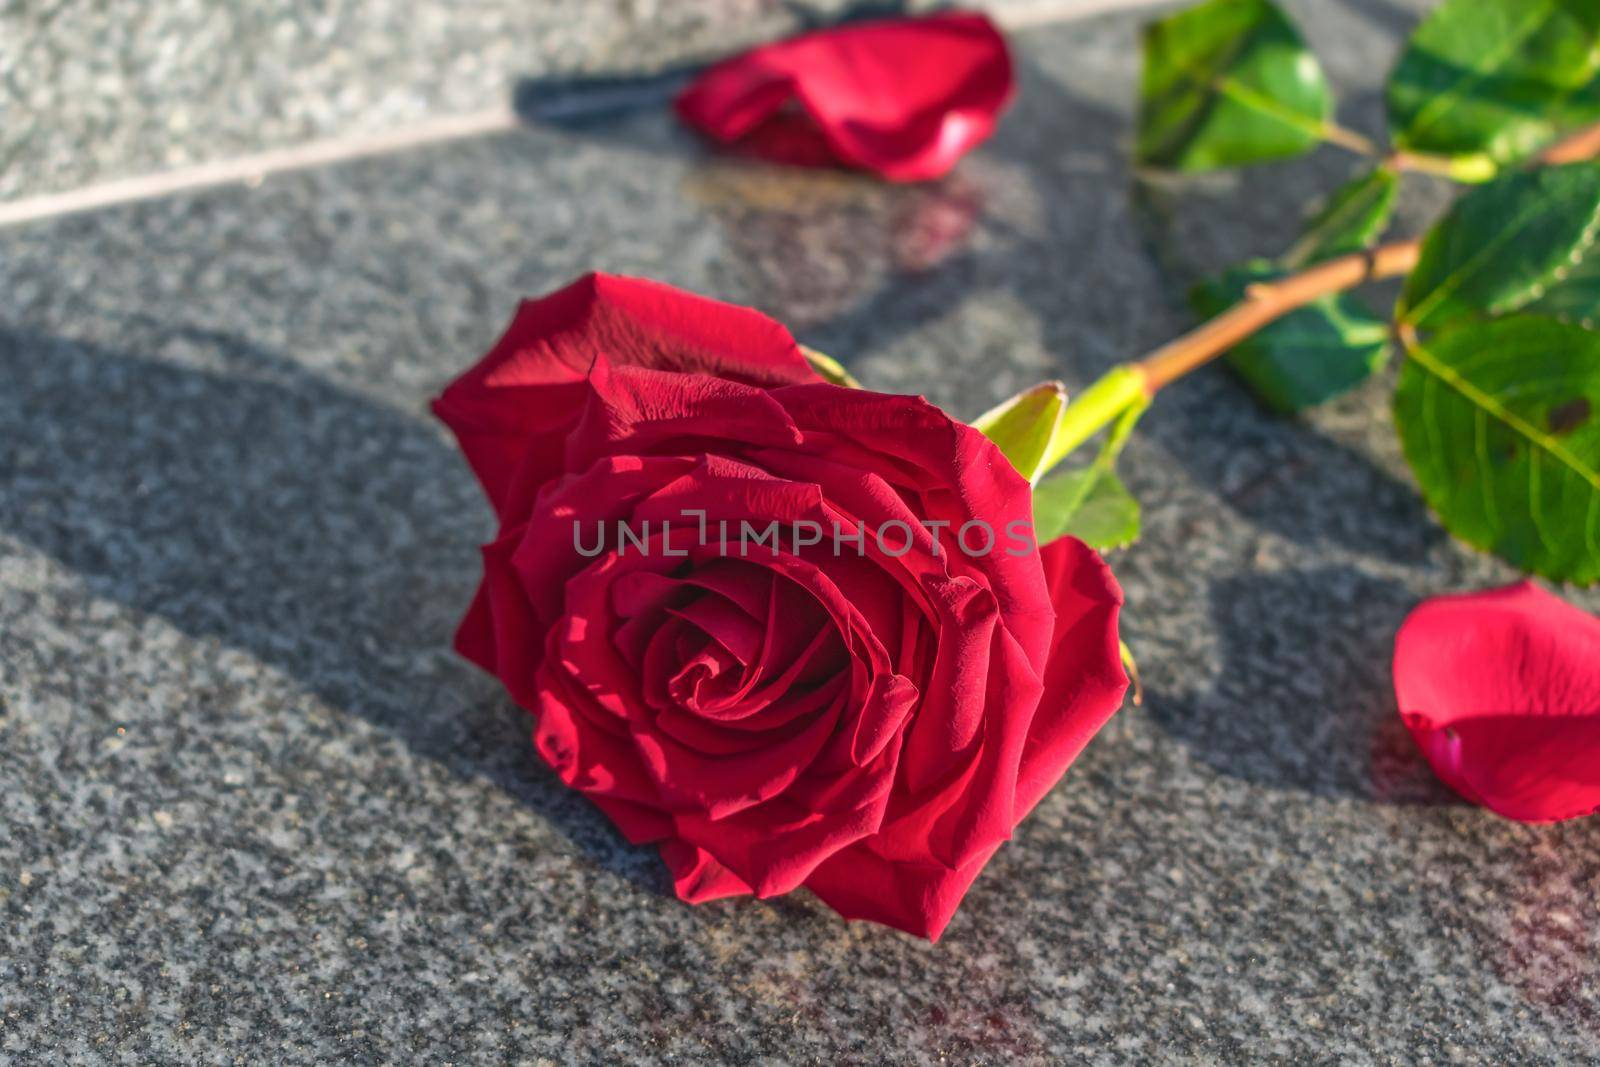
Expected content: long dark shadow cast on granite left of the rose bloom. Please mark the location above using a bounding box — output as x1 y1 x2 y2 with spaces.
0 323 670 894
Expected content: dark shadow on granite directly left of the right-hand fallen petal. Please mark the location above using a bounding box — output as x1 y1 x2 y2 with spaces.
1149 566 1461 805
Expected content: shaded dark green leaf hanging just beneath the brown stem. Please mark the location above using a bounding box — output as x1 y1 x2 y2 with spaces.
1189 259 1389 414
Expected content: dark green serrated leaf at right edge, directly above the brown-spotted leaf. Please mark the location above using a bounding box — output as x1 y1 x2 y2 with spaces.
1397 163 1600 328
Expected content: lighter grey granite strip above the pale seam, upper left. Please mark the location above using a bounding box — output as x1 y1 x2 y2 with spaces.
0 0 1100 200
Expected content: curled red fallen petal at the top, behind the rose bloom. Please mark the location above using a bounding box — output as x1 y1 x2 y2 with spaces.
677 11 1013 181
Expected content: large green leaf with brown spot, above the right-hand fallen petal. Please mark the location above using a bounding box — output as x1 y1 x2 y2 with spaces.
1395 315 1600 584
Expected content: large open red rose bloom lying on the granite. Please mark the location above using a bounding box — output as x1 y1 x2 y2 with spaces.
434 275 1126 937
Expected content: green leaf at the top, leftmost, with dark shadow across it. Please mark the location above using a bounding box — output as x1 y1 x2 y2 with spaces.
1136 0 1333 171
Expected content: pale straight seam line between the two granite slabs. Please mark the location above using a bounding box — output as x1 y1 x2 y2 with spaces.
0 0 1168 226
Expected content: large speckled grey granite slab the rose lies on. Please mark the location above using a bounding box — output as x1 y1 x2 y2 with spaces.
0 0 1600 1065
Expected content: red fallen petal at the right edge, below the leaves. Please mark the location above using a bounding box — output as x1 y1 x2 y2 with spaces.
1394 582 1600 822
